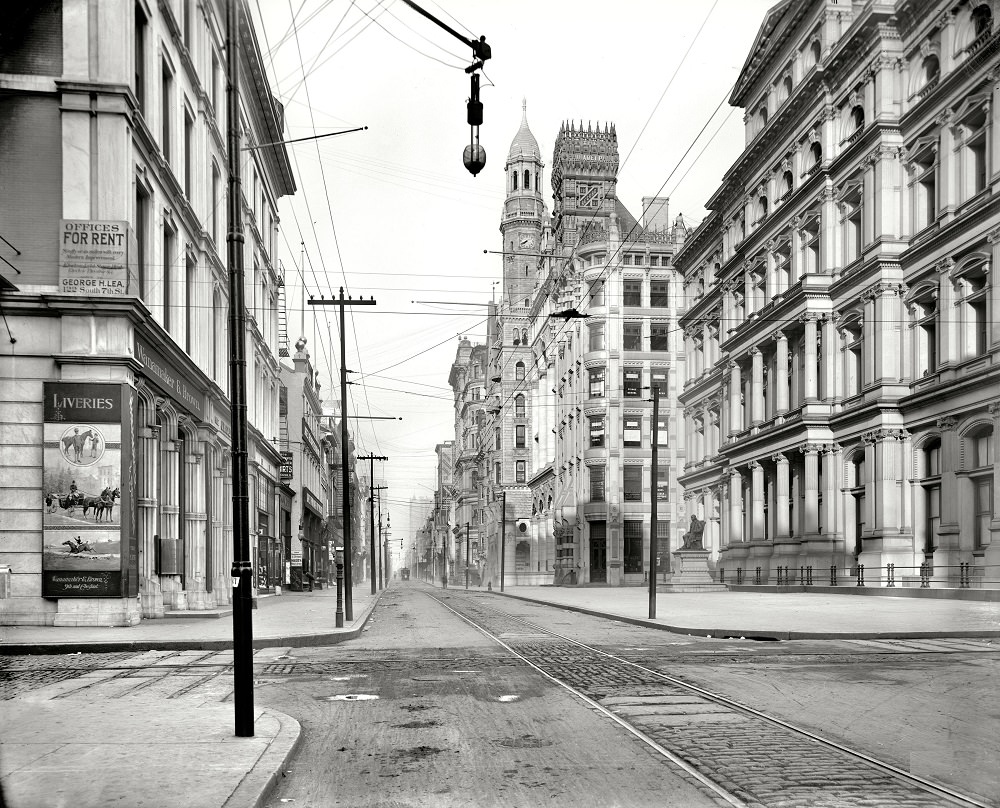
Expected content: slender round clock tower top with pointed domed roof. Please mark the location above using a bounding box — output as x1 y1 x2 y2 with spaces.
500 102 545 308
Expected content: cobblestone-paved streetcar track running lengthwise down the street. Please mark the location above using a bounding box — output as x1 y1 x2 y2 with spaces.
426 592 989 808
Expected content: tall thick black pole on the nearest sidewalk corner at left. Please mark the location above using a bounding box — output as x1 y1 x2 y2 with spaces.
226 0 254 738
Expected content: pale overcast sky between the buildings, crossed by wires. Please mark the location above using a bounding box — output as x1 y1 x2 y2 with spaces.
250 0 776 560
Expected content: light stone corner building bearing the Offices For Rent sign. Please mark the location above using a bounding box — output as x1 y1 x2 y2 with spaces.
0 0 295 625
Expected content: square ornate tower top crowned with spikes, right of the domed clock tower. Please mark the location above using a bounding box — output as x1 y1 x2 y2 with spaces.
552 121 618 248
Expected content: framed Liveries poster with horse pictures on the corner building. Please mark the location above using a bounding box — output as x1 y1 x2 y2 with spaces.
42 382 138 598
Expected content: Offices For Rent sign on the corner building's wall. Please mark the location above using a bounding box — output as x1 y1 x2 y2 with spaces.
59 219 129 297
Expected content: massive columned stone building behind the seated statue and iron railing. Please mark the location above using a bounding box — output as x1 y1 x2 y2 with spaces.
675 0 1000 586
